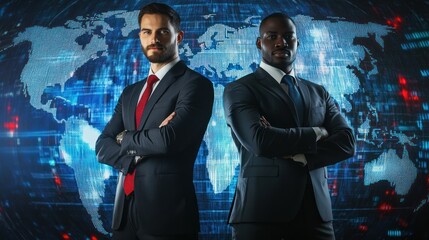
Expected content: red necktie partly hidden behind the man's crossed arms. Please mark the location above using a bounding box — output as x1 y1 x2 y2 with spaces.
124 75 159 196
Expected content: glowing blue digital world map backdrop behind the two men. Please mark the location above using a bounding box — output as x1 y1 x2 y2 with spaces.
0 1 429 240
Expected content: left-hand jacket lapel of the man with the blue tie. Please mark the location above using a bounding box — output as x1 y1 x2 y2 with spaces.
255 68 300 126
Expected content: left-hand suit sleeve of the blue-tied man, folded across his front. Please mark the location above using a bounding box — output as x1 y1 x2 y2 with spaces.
223 82 316 157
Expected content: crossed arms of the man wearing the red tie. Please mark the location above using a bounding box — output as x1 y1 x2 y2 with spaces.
96 79 214 172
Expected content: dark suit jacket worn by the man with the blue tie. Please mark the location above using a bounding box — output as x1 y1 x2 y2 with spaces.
224 68 355 224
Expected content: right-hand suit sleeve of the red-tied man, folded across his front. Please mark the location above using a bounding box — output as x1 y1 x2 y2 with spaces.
121 76 214 157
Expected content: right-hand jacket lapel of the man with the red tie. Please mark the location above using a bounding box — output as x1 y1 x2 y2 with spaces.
139 61 187 129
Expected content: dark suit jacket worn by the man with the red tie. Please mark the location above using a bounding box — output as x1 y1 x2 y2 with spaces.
96 61 214 235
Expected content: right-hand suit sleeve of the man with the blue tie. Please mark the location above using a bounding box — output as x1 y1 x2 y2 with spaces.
305 89 355 170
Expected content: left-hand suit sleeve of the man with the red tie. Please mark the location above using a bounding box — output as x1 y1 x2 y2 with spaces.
95 90 132 173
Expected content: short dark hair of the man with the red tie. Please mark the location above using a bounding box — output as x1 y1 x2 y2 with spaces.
138 3 180 32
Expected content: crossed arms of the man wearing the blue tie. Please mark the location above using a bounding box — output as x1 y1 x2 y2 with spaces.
224 81 355 169
